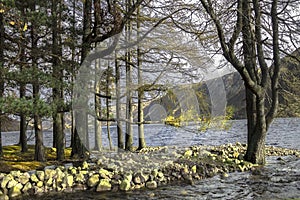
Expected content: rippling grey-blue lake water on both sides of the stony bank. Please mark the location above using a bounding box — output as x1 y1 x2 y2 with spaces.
2 118 300 200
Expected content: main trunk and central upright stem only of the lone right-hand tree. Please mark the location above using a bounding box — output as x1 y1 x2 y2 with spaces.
242 1 267 164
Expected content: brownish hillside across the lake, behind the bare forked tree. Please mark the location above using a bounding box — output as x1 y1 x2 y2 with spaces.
145 49 300 120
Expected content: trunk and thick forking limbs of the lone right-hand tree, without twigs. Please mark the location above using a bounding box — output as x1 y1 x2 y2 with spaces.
201 0 280 164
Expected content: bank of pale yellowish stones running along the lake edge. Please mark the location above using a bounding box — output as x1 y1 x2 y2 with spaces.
0 143 300 200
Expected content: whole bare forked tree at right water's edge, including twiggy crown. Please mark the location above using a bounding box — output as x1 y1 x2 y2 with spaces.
192 0 299 164
